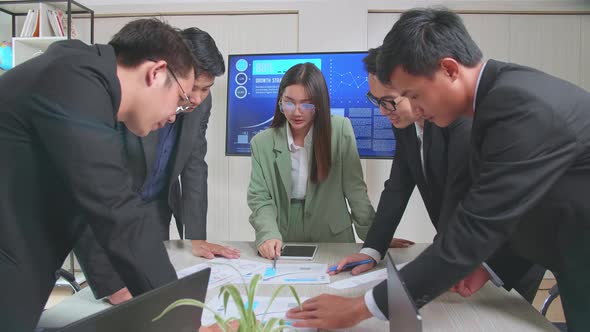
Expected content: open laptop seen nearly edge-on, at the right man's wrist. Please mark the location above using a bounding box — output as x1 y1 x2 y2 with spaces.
387 253 422 332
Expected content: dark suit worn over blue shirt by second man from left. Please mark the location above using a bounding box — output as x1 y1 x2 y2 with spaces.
74 95 211 298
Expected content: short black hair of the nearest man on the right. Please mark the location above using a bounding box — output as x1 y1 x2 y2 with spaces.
377 8 483 83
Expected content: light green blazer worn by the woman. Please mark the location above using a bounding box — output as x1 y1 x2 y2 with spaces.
248 115 375 247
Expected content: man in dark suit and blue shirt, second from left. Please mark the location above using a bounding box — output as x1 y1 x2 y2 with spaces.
74 28 240 304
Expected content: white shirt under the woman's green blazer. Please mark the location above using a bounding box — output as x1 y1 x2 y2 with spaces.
287 123 313 199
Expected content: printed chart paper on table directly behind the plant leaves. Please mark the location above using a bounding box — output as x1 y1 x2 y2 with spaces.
201 296 317 332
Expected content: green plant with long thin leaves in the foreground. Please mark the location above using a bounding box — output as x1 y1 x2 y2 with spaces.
152 265 301 332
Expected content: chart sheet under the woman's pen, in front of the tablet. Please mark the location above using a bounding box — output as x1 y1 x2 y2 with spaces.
246 263 330 285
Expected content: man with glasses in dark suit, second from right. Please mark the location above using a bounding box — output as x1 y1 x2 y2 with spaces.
332 48 545 303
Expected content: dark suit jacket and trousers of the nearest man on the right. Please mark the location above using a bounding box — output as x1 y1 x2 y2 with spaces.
373 60 590 332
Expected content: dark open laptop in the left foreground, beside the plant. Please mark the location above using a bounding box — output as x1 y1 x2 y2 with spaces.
57 268 211 332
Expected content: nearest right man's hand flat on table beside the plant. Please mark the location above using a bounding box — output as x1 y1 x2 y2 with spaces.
287 294 372 329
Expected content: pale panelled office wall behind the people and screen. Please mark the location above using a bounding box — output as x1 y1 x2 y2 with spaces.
77 0 590 242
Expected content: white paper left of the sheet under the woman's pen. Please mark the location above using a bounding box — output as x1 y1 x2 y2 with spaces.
176 258 267 289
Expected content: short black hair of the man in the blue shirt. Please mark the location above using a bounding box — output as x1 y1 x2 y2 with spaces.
181 27 225 77
